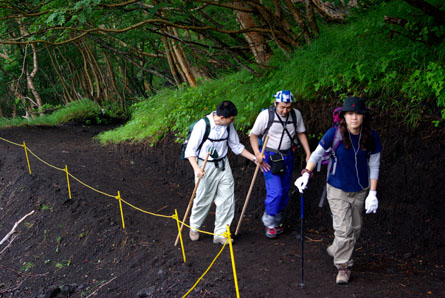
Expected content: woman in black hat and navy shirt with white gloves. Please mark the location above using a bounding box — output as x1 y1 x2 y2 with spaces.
295 97 382 284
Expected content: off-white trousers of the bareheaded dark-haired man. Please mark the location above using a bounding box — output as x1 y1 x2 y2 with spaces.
190 157 235 234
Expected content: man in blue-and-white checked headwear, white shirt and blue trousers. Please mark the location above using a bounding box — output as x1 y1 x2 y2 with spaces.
250 90 311 238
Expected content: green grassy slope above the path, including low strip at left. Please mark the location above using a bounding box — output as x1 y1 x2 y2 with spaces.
0 0 445 143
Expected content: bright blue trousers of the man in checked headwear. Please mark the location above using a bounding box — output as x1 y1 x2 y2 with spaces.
264 150 294 217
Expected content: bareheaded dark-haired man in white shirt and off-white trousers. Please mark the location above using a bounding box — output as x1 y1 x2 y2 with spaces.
184 101 263 244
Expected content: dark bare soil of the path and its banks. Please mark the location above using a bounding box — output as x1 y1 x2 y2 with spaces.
0 117 445 297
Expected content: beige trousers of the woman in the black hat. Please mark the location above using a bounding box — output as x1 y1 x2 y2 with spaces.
327 184 368 268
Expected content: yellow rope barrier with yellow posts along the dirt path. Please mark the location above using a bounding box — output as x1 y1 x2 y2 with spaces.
0 137 239 298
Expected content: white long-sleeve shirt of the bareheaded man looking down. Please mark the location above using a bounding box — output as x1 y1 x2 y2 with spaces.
184 111 245 161
